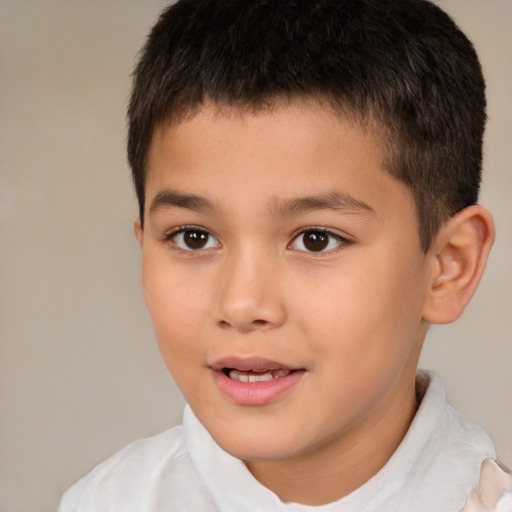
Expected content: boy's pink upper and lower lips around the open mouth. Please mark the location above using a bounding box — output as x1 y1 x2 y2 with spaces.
211 358 305 406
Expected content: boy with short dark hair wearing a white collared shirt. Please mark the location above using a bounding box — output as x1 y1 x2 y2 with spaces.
61 0 508 512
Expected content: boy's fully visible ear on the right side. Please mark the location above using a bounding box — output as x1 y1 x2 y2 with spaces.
423 205 494 324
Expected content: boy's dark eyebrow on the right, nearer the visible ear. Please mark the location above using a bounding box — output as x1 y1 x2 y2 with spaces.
271 191 375 216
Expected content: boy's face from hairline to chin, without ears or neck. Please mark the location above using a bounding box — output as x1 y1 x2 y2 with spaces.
136 103 430 460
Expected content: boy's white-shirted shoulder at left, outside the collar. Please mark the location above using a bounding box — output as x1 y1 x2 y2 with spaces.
59 426 214 512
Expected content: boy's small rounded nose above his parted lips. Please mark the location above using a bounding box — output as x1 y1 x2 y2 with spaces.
210 251 286 332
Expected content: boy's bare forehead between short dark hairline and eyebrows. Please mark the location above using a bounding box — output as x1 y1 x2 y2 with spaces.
146 101 408 222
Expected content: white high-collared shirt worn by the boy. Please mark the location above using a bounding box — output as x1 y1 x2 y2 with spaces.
60 372 495 512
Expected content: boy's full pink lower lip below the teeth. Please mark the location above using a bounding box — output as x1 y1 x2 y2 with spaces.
213 370 305 405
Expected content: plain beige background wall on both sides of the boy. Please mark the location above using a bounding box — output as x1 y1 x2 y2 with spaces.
0 0 512 512
